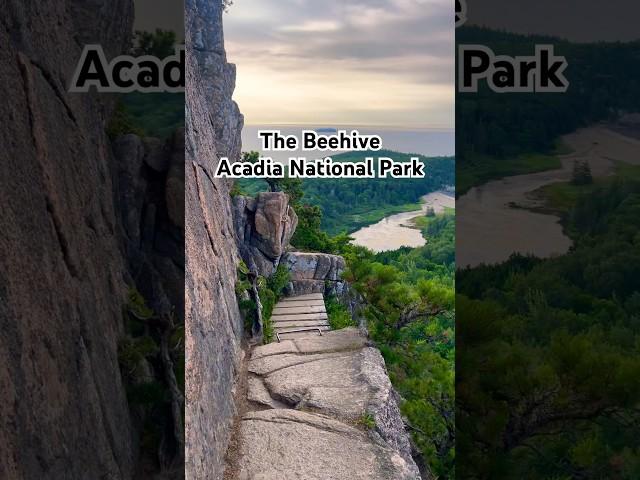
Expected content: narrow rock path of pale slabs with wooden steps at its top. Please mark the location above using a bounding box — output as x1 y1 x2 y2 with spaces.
234 294 421 480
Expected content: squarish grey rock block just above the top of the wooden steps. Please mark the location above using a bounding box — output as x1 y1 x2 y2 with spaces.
282 252 345 296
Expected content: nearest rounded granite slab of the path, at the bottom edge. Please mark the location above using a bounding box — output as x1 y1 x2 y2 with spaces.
238 410 412 480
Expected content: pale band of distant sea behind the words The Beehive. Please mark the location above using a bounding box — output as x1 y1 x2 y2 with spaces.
242 125 455 162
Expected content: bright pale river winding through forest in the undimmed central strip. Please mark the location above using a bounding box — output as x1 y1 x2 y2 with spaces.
351 192 455 253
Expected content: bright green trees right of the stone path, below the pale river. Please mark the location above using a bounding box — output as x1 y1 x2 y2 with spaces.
352 212 456 479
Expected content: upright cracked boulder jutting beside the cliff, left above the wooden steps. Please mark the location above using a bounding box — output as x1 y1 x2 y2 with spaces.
233 192 298 277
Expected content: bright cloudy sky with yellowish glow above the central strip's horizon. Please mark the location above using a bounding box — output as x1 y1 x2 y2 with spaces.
224 0 455 129
